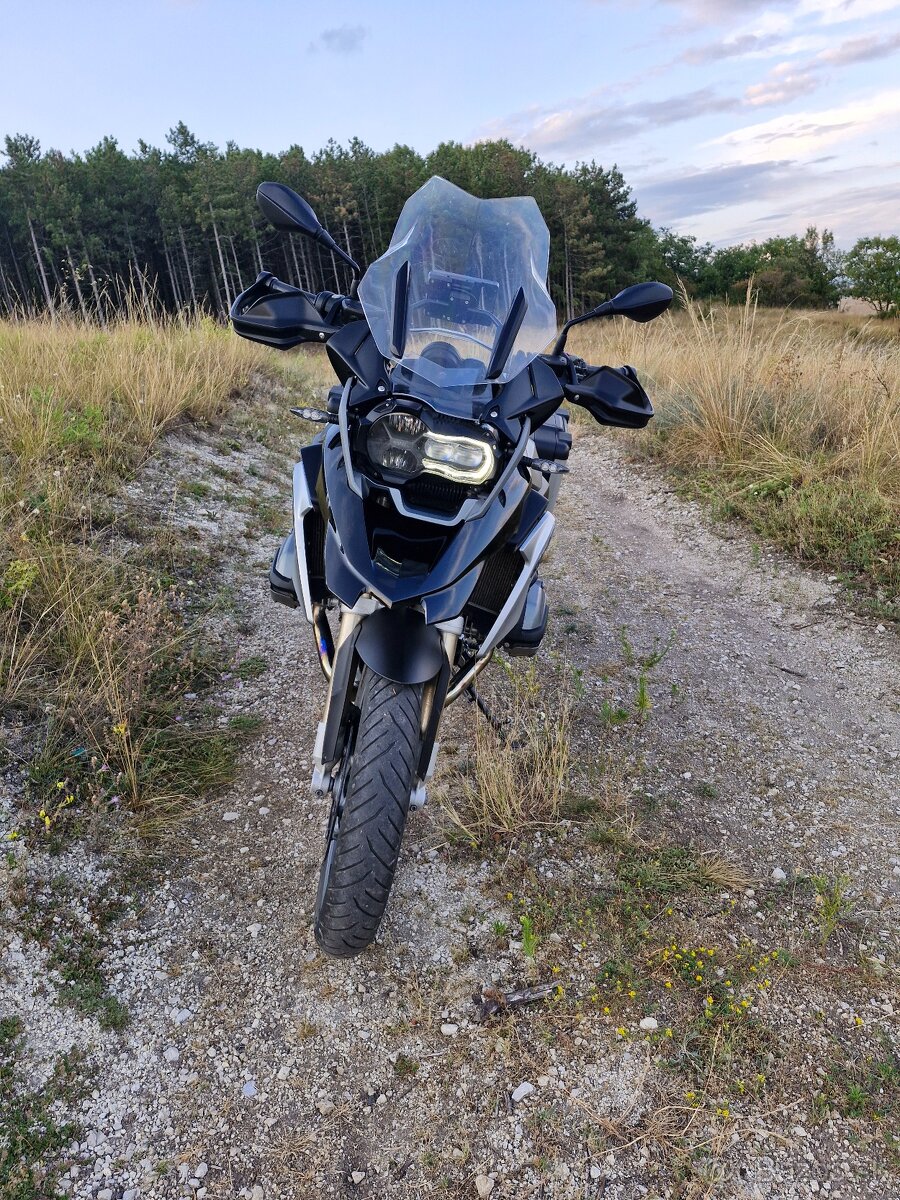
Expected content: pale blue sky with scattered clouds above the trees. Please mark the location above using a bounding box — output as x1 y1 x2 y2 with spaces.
0 0 900 246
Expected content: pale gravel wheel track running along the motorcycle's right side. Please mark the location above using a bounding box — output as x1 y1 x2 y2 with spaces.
546 437 900 902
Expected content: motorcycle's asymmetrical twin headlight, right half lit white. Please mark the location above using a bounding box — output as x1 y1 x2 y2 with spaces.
366 413 497 485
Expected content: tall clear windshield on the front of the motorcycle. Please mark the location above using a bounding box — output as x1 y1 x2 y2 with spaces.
359 175 557 398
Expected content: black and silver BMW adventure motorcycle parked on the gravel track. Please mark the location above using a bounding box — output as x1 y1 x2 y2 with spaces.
230 178 672 956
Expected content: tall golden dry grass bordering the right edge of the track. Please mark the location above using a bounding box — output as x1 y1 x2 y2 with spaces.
572 299 900 605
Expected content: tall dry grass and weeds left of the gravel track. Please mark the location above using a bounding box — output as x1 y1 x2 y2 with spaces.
0 313 264 832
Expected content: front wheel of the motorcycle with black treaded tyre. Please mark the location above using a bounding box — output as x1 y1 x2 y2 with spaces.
316 667 422 958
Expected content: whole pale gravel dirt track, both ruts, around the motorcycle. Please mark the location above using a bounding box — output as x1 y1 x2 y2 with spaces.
0 420 900 1200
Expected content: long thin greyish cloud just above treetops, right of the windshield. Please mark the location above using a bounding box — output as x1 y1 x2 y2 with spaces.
484 88 740 155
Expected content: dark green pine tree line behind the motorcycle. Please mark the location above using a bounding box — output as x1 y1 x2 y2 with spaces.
0 124 896 322
